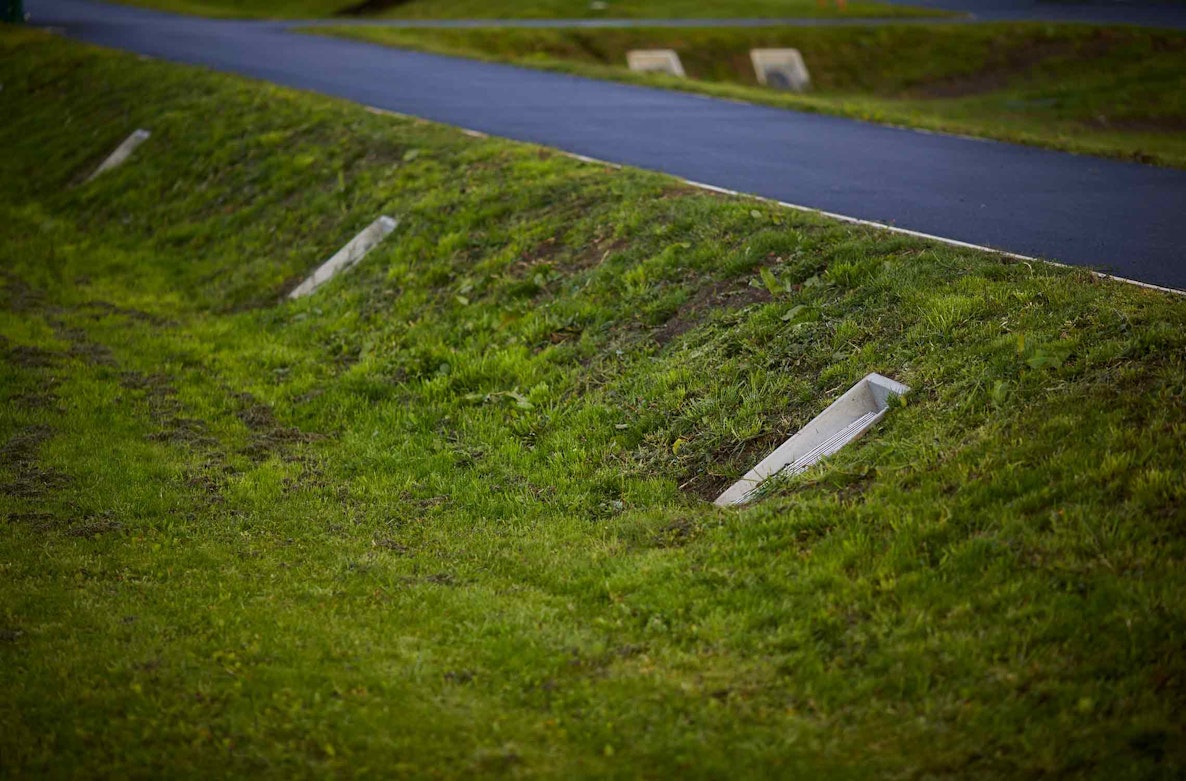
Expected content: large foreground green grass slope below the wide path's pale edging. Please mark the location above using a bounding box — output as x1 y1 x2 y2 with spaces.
0 31 1186 777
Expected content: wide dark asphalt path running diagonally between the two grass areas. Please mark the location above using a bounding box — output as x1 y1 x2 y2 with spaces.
27 0 1186 289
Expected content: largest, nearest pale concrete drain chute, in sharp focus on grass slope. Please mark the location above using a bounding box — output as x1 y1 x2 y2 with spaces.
713 373 910 507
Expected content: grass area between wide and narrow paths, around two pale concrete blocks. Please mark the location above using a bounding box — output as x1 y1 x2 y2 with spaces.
317 24 1186 167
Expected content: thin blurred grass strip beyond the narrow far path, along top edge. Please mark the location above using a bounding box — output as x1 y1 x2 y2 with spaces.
104 0 951 19
